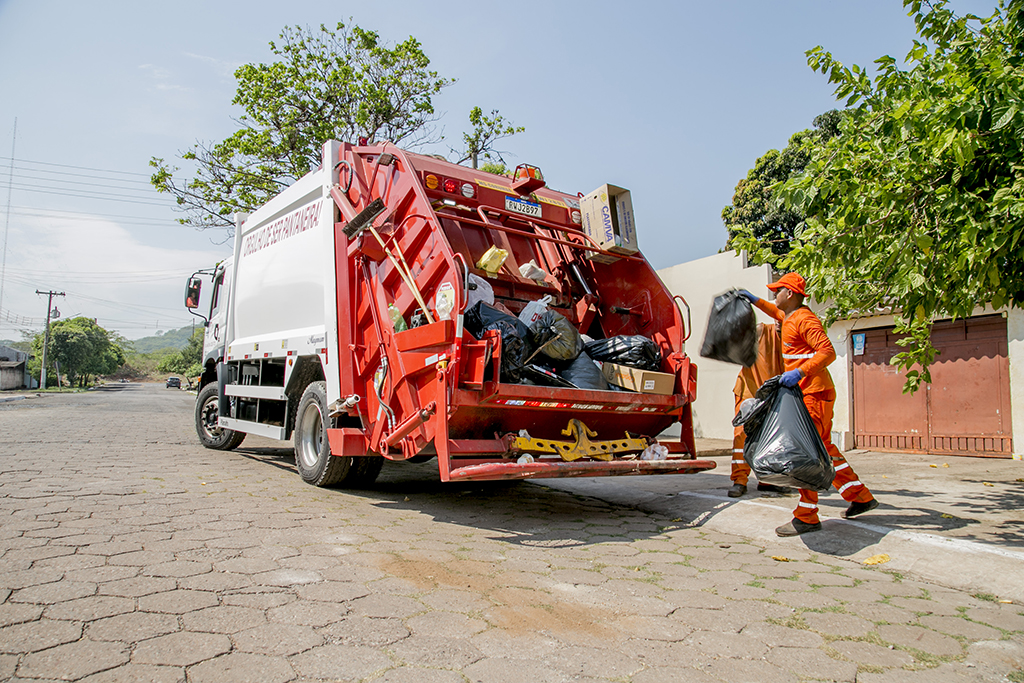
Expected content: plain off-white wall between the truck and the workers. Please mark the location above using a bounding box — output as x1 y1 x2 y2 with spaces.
657 252 774 440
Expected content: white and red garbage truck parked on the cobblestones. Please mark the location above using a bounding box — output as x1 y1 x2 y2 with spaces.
185 141 715 486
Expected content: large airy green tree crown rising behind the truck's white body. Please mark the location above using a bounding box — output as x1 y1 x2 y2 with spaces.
150 23 454 229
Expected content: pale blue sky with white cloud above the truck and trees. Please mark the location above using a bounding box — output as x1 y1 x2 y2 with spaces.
0 0 994 339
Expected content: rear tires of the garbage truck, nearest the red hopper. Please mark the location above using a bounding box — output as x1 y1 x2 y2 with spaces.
293 382 384 487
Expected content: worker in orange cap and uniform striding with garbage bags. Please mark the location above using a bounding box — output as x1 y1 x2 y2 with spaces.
740 272 879 537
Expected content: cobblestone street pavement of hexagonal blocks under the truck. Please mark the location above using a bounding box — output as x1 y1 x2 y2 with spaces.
0 385 1024 683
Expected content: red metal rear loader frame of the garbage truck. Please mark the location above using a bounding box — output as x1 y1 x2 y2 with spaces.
328 143 715 481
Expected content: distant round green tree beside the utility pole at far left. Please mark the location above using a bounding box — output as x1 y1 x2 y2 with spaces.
30 316 127 387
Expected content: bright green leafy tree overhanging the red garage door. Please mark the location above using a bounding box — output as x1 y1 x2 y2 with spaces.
745 0 1024 391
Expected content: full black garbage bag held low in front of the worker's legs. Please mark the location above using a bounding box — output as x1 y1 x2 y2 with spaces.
743 383 836 490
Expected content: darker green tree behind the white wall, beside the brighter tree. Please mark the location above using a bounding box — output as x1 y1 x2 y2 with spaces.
722 110 842 265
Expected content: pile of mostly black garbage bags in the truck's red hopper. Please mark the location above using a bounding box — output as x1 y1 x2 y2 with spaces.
464 275 662 391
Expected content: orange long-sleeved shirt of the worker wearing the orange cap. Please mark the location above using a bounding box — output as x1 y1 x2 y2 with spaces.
754 299 836 393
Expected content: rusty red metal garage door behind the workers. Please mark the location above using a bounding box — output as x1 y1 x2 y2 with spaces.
852 315 1013 458
